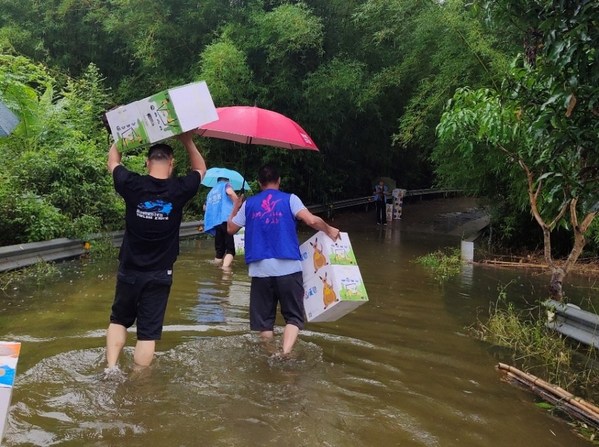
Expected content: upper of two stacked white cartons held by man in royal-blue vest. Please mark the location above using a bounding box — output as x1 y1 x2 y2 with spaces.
300 231 358 280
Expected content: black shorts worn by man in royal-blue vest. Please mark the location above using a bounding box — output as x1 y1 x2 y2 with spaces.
250 272 304 331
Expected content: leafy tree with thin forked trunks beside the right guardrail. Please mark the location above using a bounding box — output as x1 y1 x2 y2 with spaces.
435 0 599 299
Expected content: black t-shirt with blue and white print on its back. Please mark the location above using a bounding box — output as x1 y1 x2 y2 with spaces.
112 165 201 270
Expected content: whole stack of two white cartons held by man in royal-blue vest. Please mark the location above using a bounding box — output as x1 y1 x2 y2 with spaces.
300 231 368 322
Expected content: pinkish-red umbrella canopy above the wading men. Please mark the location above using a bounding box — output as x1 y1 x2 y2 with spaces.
195 106 318 151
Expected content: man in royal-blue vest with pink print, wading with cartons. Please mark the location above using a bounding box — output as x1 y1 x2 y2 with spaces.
227 164 339 356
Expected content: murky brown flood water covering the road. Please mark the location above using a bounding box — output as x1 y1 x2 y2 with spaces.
0 201 590 447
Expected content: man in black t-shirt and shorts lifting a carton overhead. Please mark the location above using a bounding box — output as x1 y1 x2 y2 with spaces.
106 132 206 370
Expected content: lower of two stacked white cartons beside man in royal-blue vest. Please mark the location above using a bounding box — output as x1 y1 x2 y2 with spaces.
304 265 368 323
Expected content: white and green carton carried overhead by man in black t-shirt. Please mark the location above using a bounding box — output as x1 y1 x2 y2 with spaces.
106 81 218 151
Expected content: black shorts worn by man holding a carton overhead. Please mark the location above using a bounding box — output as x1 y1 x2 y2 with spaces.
110 270 173 340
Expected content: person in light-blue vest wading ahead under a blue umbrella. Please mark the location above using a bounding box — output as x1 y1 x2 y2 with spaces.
204 177 237 270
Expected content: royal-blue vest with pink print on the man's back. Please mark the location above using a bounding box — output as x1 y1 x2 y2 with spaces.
245 189 301 264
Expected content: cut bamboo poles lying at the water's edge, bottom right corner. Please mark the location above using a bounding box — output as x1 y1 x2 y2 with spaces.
497 363 599 428
